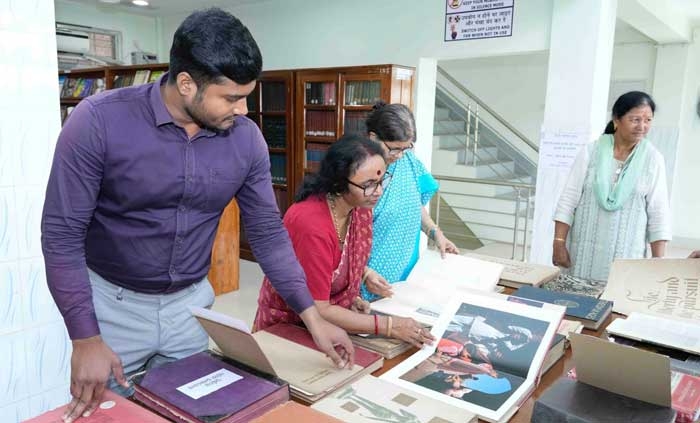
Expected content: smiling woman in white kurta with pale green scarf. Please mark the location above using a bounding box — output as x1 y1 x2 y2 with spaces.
552 91 671 281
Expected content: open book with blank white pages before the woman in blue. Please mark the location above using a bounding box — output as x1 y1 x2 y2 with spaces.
372 250 503 326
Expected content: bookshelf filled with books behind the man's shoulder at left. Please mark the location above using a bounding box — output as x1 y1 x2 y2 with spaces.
58 63 168 122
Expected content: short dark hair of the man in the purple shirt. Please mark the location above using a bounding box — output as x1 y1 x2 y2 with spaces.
168 8 262 89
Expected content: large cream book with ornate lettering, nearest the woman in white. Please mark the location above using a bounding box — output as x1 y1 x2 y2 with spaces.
602 258 700 322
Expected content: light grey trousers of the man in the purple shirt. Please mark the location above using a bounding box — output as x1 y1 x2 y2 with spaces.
88 270 214 396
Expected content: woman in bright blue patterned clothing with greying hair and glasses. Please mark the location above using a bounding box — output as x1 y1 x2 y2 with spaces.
362 102 459 300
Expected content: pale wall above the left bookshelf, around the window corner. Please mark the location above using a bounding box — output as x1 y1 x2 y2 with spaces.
55 0 161 65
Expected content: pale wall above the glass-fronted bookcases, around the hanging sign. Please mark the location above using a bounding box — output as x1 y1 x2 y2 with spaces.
161 0 552 70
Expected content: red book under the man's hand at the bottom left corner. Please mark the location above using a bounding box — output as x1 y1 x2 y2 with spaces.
25 390 168 423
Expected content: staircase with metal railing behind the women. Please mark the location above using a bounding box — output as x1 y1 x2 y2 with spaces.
431 68 537 258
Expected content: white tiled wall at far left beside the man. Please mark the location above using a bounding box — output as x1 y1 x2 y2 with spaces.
0 0 70 423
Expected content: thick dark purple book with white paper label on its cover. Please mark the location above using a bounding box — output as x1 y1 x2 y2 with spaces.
134 352 289 423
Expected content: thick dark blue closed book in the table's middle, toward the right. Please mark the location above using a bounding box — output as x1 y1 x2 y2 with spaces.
513 286 613 330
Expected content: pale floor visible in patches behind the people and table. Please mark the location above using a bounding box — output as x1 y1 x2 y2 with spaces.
213 243 700 327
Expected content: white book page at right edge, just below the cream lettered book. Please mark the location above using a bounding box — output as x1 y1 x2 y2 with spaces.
605 312 700 355
